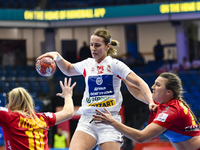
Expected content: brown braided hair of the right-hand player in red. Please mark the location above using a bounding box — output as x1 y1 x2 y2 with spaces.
159 72 200 127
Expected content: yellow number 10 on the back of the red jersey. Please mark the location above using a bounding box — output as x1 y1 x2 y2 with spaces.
25 129 44 150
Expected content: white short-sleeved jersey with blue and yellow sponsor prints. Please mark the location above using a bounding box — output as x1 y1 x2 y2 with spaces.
74 56 132 115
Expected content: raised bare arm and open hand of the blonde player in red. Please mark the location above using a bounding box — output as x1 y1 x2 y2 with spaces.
55 78 76 124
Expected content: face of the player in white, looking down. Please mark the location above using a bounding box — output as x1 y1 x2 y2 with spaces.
90 35 110 62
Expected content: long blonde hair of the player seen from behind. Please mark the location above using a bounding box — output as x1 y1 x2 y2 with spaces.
6 87 45 128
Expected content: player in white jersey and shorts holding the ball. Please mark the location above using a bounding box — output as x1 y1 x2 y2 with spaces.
38 29 156 150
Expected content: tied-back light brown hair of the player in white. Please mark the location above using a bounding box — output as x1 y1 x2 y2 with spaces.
93 28 119 56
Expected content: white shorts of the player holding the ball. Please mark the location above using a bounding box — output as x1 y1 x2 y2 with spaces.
76 114 123 144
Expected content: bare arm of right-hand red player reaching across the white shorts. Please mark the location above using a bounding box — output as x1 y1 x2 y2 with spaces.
93 108 167 143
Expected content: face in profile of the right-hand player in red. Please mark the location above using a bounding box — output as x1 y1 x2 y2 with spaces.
151 77 169 104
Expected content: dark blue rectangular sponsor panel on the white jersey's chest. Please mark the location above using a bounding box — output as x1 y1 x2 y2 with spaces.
88 75 114 97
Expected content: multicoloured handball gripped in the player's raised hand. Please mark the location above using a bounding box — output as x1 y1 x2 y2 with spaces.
35 57 56 77
